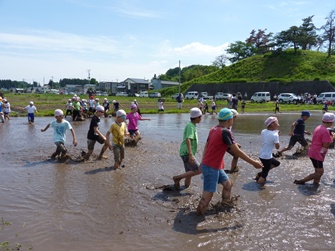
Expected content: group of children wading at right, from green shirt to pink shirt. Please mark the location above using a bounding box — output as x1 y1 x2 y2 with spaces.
172 108 335 215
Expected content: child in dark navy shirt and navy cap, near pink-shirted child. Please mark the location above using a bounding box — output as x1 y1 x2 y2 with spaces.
273 111 311 158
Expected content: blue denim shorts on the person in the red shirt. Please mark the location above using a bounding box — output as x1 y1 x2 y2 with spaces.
201 164 229 193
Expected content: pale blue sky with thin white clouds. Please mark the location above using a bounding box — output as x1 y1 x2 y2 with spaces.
0 0 335 85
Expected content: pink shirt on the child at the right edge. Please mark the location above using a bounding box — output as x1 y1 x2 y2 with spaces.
308 125 333 161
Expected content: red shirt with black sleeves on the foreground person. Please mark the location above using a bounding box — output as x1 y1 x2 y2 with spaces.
202 126 235 170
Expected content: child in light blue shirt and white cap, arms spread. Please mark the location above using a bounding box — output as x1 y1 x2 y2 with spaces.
41 109 77 159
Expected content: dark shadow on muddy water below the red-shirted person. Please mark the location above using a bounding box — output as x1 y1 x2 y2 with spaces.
172 208 243 235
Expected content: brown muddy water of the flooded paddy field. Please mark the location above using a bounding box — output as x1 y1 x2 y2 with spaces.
0 112 335 251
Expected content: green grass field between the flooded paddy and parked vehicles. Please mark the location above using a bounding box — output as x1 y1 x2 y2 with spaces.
4 93 333 116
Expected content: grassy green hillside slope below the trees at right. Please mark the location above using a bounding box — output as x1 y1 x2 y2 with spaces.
185 50 335 86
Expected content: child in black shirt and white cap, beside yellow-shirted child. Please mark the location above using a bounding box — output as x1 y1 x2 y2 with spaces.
82 105 107 160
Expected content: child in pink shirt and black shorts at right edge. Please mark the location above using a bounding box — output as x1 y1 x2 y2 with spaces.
294 112 335 185
